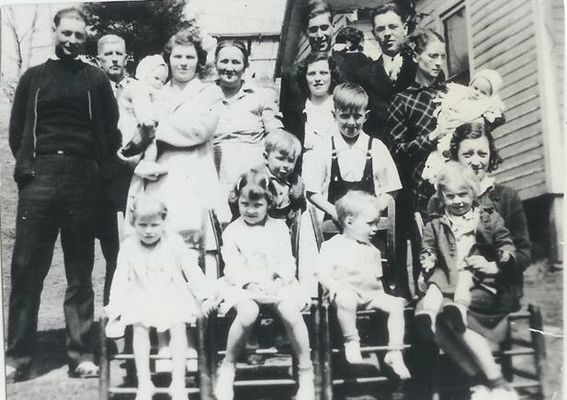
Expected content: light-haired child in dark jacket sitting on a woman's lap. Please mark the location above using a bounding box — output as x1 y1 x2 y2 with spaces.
415 161 515 338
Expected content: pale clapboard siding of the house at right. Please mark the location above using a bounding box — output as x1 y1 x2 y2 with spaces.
417 0 548 199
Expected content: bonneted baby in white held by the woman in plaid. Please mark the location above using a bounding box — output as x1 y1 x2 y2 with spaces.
422 69 505 184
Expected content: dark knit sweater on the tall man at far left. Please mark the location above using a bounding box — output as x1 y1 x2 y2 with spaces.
9 60 120 183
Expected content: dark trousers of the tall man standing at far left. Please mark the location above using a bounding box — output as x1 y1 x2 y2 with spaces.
6 154 100 369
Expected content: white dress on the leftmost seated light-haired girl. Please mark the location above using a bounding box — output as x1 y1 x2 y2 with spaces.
105 234 211 332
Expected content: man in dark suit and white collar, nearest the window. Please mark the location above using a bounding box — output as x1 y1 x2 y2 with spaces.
354 3 416 142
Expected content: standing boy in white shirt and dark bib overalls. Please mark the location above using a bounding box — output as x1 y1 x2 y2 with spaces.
303 82 406 286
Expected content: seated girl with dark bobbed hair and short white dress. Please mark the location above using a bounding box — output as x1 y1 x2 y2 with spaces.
215 170 315 400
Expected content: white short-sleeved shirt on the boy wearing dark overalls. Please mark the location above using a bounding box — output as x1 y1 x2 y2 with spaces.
303 131 402 197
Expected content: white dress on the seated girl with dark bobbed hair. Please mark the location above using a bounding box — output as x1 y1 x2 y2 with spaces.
219 217 310 311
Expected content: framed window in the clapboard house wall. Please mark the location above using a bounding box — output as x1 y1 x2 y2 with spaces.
441 5 470 85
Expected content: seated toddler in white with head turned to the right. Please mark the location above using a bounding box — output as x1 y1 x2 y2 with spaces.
317 191 410 379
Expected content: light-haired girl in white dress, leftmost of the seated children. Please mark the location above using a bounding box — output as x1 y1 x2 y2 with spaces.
105 195 216 400
